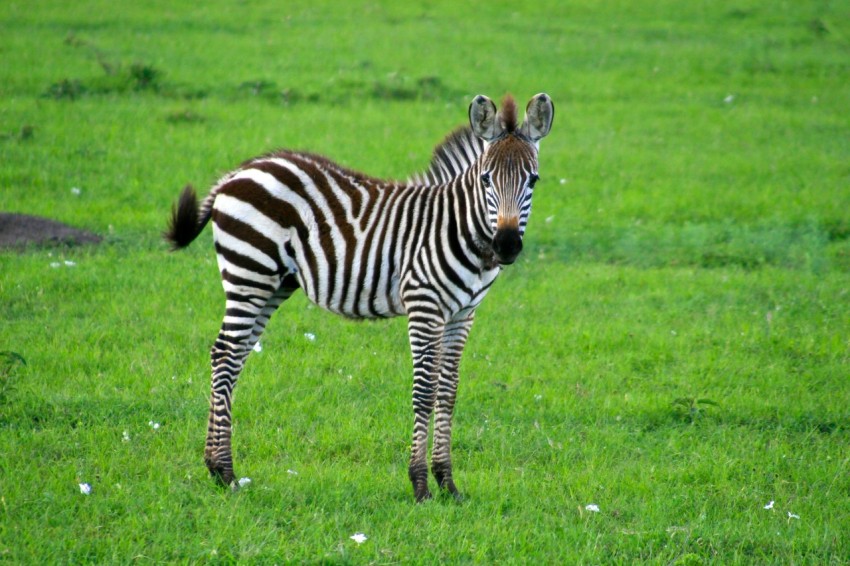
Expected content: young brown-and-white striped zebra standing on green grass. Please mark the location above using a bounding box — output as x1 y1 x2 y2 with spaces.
164 93 555 502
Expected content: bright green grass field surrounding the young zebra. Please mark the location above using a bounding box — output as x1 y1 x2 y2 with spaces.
0 0 850 565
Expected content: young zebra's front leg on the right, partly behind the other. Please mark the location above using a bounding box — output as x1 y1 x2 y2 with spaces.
431 313 474 498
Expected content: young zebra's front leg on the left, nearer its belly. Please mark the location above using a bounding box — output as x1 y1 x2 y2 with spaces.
408 313 445 502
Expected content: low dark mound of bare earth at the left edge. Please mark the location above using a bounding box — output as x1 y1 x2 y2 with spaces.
0 212 101 249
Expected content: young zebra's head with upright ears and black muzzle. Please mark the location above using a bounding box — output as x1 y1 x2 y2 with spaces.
469 93 555 265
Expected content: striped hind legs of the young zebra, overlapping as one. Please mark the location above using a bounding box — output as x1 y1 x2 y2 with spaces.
204 277 298 485
